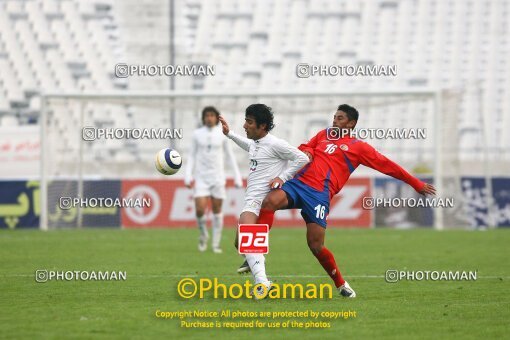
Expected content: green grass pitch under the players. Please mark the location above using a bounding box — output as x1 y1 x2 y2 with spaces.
0 228 510 339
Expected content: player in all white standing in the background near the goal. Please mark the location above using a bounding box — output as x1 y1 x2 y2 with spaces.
184 106 243 253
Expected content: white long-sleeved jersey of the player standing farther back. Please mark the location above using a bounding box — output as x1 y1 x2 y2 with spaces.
184 124 242 186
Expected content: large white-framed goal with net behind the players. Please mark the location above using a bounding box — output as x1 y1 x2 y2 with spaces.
41 90 468 229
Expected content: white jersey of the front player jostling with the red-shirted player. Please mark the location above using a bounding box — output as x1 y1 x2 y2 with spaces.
227 131 309 205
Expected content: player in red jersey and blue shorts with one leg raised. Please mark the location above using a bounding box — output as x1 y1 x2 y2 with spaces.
242 104 436 297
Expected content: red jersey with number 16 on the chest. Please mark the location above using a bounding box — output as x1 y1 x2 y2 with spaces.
295 130 425 200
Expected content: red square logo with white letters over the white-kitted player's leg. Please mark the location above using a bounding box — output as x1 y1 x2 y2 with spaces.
237 224 269 254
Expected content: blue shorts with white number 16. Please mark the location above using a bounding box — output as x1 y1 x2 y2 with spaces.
282 178 329 228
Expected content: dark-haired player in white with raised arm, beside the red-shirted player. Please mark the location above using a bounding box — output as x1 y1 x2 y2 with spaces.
220 104 309 290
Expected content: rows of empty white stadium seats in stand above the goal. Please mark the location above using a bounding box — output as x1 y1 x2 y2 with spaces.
0 0 510 159
